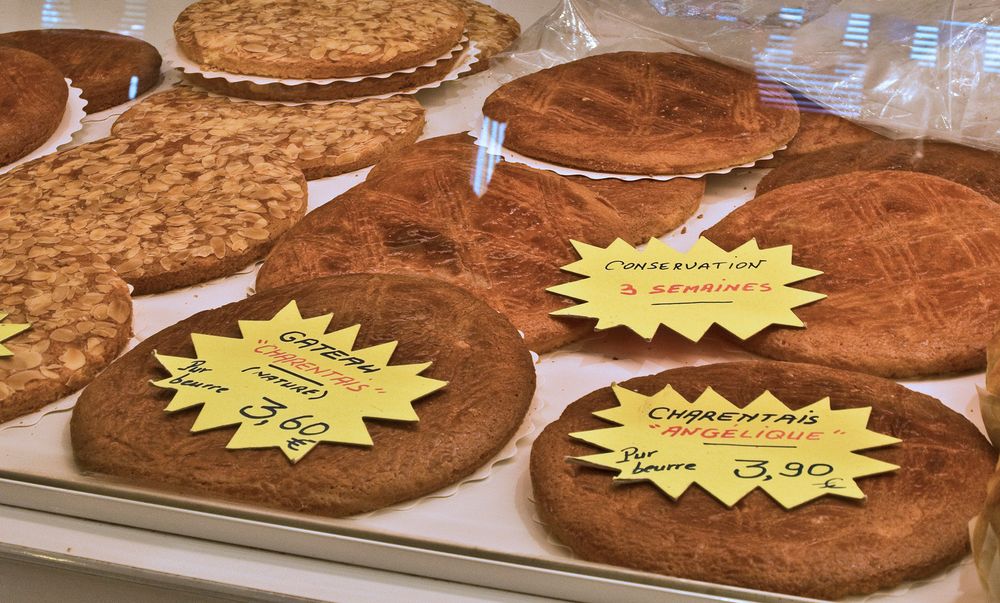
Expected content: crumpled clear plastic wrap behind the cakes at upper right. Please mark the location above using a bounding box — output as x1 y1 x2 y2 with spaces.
494 0 1000 150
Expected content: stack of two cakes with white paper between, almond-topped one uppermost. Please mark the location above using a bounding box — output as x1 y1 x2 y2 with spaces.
174 0 474 102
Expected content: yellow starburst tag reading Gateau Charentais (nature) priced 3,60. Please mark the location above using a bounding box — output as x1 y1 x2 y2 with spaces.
152 301 447 463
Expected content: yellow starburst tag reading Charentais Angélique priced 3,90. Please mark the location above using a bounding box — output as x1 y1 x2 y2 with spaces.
570 385 900 509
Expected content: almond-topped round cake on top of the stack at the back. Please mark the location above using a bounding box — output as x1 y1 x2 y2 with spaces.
174 0 466 79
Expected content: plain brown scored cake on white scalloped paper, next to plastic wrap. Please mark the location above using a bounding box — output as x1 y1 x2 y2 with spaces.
483 52 799 174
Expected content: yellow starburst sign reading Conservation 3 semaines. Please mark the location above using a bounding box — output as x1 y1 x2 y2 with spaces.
548 238 826 341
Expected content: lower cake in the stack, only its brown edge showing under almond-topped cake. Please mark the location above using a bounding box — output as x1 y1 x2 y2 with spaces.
184 43 475 103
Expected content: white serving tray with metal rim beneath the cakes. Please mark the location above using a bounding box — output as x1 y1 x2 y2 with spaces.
0 31 983 603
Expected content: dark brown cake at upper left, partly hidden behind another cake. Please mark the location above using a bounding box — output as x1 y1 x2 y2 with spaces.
0 29 161 113
